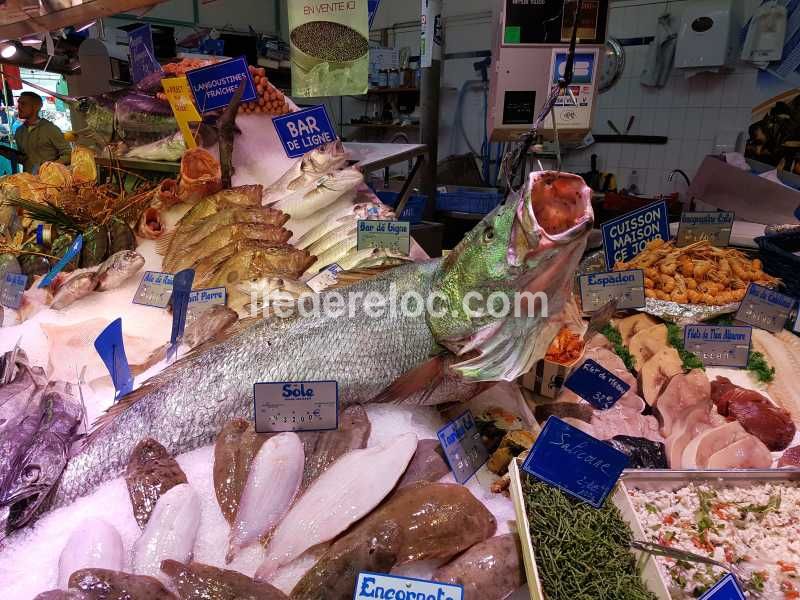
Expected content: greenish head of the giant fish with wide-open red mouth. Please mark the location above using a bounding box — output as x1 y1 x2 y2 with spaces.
428 171 594 381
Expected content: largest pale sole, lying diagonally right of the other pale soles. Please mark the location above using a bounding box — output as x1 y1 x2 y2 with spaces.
256 433 417 581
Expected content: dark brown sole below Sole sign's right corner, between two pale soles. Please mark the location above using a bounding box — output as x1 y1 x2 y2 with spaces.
300 405 372 492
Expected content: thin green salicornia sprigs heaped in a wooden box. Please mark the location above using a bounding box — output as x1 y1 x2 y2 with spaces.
522 474 656 600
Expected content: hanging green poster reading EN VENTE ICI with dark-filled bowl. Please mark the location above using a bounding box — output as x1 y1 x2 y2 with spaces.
288 0 369 98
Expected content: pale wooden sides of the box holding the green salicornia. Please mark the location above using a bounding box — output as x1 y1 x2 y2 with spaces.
509 459 672 600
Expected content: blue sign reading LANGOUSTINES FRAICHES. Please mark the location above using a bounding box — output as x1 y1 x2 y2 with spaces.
186 56 256 113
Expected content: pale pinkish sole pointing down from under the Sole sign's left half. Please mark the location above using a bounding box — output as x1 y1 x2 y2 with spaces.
225 433 305 563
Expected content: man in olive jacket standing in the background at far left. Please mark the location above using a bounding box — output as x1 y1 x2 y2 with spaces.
14 92 72 174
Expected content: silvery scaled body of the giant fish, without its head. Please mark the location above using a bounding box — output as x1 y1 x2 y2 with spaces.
53 261 439 507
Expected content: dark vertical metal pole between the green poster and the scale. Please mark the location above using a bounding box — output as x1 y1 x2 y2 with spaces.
420 0 443 219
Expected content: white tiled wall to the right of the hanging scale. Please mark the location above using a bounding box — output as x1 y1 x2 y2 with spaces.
565 0 757 195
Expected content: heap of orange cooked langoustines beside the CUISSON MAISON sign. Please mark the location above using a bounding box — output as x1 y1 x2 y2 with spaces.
614 240 780 306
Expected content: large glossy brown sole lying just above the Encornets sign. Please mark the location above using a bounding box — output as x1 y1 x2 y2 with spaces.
291 483 497 600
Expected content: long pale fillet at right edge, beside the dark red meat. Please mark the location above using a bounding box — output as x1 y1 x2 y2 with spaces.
753 328 800 426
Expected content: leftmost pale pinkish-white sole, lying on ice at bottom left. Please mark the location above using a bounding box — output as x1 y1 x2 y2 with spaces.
58 517 125 590
